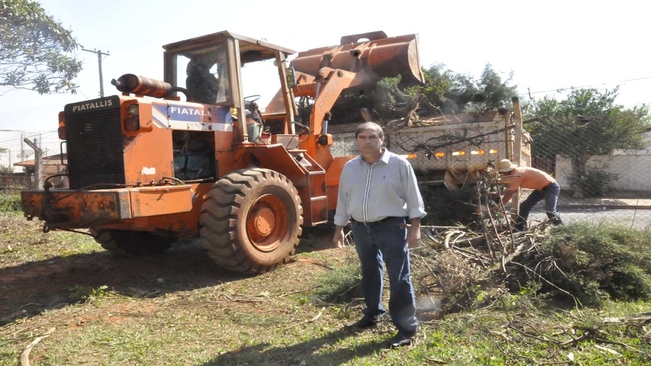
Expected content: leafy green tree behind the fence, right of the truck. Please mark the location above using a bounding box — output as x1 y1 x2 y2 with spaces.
525 88 649 196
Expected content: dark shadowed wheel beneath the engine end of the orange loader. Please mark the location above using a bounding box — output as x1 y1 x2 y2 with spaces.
90 228 174 256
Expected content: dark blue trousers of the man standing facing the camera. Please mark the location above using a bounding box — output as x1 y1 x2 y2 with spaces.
351 217 418 333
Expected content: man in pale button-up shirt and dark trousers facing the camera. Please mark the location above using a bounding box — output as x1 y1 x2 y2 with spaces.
333 122 426 347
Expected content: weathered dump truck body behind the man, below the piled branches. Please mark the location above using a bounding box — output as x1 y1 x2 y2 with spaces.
331 101 532 190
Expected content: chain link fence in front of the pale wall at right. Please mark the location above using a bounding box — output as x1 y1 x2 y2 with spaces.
525 116 651 230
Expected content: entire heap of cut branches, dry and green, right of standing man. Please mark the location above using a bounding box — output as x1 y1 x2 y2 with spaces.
411 180 651 364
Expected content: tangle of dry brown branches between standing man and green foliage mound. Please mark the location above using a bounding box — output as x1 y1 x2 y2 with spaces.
412 178 581 318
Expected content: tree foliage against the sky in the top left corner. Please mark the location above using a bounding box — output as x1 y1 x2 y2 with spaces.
0 0 81 94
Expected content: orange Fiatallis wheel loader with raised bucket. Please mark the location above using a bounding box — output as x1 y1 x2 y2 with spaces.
21 31 423 273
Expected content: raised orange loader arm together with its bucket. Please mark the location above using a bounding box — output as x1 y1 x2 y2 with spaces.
291 31 424 169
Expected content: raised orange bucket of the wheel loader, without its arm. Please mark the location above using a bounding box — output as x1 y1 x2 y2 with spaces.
292 31 424 85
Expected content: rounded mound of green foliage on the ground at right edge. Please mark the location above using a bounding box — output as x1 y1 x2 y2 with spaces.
521 223 651 306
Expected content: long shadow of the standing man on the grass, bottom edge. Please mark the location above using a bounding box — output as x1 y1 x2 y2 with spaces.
202 329 384 366
